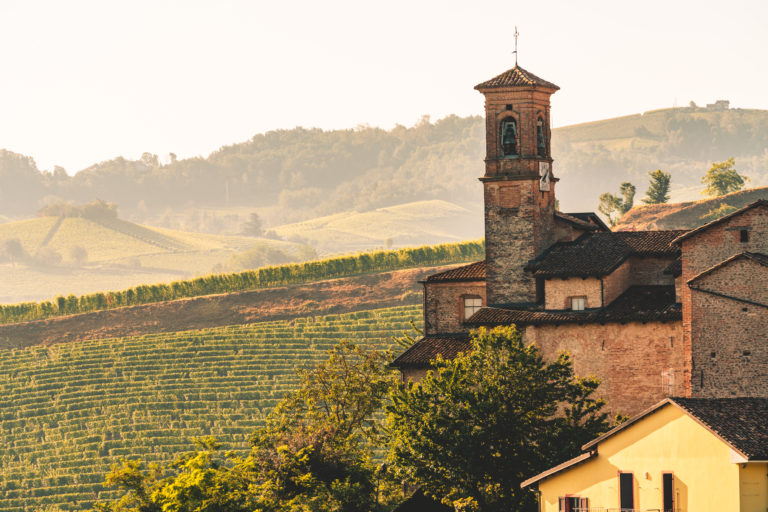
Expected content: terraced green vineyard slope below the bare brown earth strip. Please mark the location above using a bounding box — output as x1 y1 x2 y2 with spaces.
0 306 421 511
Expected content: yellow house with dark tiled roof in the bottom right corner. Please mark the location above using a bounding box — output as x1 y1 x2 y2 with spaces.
522 398 768 512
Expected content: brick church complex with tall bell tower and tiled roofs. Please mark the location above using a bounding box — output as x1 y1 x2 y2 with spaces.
393 66 768 414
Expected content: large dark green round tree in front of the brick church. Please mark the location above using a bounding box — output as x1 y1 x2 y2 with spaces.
388 327 609 511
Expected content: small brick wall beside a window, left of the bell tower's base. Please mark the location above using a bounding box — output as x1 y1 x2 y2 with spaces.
424 281 486 334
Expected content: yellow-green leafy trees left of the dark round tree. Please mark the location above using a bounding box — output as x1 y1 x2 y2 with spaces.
96 342 394 512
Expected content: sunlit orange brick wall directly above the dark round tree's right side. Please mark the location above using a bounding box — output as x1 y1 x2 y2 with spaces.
523 322 685 415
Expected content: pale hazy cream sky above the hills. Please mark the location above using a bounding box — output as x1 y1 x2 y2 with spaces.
0 0 768 173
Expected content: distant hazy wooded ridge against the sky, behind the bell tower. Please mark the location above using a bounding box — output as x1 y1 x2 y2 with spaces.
0 107 768 229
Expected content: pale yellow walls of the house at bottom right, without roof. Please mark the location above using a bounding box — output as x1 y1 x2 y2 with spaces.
539 405 756 512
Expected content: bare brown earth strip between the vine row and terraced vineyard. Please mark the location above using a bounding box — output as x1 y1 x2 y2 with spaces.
0 265 456 348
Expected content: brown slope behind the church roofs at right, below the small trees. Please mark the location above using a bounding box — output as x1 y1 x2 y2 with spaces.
613 187 768 231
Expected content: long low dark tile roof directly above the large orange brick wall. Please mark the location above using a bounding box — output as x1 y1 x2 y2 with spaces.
467 286 682 327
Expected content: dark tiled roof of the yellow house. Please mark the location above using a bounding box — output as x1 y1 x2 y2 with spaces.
671 398 768 460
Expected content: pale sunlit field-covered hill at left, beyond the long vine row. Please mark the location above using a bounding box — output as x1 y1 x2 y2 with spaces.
0 217 299 303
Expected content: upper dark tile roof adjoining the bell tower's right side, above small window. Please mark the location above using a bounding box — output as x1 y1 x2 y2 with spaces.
527 230 684 277
